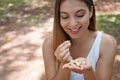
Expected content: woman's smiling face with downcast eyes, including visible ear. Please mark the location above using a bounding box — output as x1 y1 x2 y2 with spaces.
60 0 92 38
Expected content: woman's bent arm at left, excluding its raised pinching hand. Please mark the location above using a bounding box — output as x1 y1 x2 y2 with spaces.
42 38 70 80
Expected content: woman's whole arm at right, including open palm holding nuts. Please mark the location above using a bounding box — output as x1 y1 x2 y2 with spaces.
63 35 117 80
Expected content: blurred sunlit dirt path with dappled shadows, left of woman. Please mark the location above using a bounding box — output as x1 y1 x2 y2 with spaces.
0 17 51 80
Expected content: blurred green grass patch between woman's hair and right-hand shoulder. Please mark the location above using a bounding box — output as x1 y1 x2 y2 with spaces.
97 14 120 43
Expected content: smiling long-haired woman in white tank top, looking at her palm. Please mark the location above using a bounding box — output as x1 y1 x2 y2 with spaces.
43 0 117 80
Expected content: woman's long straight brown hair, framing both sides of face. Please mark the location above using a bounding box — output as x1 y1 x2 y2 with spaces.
53 0 96 69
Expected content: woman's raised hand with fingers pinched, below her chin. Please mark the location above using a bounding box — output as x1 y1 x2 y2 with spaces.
55 41 72 63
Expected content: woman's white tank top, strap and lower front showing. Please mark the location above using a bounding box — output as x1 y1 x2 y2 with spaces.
70 31 102 80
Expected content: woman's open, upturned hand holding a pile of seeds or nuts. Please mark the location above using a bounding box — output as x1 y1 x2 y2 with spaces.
62 58 92 74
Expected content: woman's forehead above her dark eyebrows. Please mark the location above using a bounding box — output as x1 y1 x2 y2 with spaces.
60 0 88 11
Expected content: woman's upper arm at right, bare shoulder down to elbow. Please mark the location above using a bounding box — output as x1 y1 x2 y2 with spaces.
96 34 117 80
